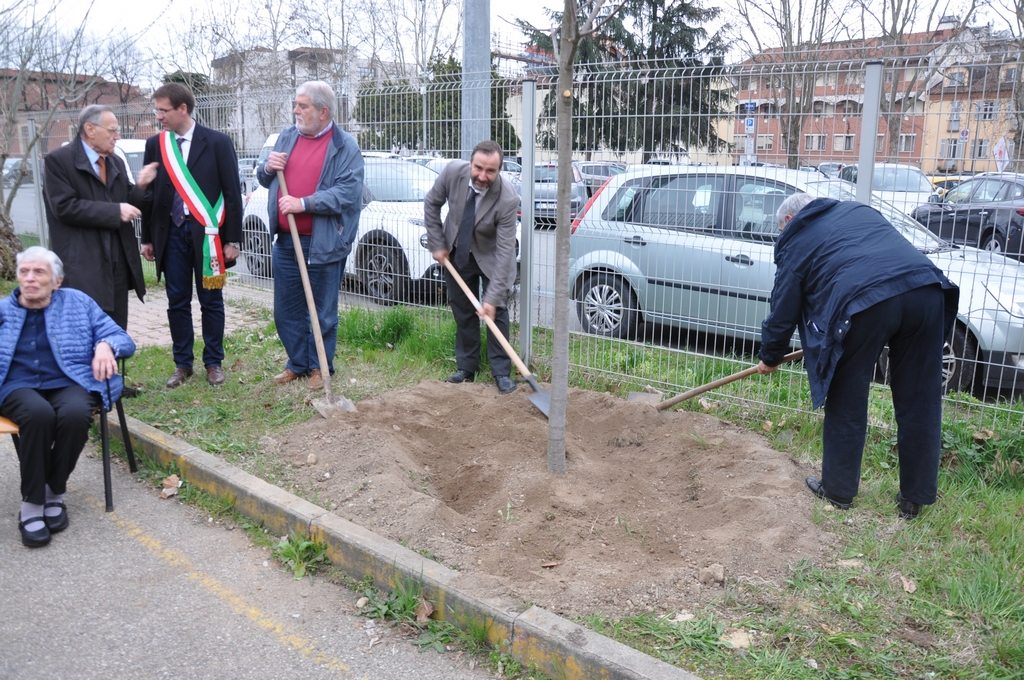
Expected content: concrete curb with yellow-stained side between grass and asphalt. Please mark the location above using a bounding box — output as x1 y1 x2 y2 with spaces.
111 418 700 680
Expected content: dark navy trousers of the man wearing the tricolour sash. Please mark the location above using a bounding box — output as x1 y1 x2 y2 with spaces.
164 222 224 369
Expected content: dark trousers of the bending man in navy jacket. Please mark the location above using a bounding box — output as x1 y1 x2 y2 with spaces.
821 286 944 505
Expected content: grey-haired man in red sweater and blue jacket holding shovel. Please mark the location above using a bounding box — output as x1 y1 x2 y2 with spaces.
256 81 364 389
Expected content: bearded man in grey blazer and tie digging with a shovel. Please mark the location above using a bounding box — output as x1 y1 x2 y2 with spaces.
423 140 519 394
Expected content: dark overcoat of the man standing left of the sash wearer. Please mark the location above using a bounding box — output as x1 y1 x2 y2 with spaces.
43 137 145 311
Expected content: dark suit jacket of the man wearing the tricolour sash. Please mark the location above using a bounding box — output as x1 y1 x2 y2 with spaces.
142 123 243 278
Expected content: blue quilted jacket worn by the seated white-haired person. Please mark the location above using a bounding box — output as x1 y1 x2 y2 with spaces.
0 288 135 411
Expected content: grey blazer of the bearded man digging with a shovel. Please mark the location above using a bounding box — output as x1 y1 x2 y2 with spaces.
423 161 519 307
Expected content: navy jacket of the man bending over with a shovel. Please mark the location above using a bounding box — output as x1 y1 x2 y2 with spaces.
759 199 959 409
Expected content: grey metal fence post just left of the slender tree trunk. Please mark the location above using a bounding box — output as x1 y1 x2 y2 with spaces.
519 80 537 366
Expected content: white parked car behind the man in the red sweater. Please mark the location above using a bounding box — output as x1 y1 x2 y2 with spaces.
242 142 519 303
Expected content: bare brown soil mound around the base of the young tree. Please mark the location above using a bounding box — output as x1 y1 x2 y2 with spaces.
263 382 833 617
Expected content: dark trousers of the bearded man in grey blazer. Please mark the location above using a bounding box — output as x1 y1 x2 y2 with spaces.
444 252 512 376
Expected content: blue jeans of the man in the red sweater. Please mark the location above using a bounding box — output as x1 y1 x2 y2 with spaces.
273 231 345 376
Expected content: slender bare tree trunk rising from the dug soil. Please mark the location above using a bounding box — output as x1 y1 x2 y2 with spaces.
548 0 579 474
